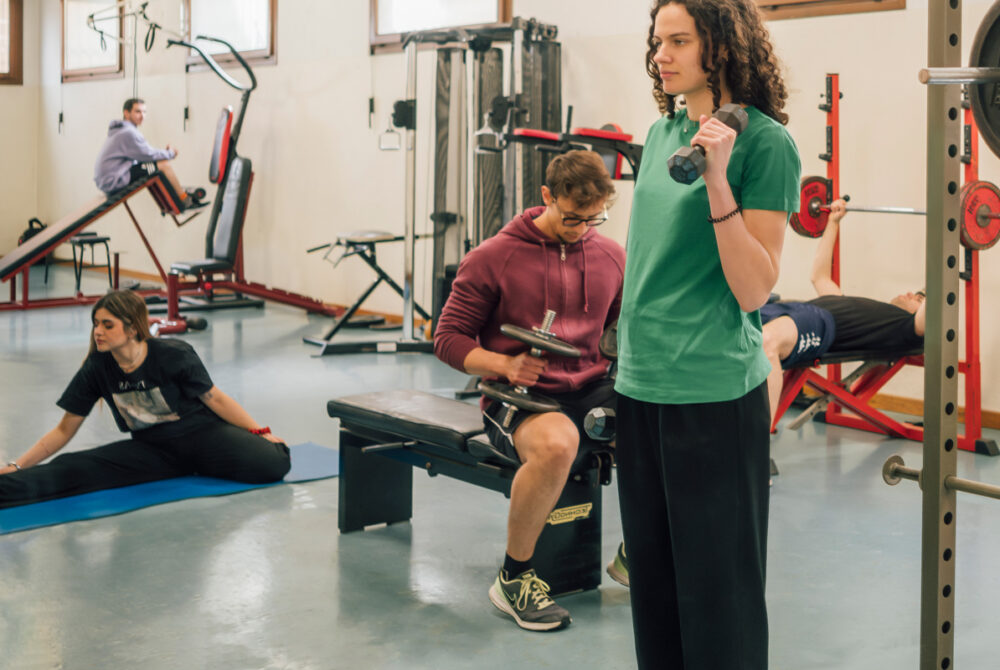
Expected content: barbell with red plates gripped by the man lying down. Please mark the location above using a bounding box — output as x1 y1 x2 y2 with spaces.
789 176 1000 250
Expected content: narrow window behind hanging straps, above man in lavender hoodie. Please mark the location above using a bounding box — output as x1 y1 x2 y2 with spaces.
62 0 125 81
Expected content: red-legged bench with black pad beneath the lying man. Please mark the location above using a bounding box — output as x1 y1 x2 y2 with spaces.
771 349 1000 456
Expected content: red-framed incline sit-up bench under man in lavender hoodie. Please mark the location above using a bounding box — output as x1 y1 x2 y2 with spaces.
0 172 197 310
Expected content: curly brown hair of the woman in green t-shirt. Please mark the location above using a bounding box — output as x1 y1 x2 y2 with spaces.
646 0 788 125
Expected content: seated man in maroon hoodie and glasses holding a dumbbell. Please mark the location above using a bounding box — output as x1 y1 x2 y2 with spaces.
434 151 625 630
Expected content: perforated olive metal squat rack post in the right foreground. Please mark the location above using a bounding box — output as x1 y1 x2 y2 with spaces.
883 0 1000 670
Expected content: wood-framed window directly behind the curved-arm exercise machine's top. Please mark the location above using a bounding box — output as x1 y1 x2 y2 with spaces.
184 0 278 66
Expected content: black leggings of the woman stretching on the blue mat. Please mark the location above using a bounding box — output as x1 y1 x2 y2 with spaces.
0 420 291 508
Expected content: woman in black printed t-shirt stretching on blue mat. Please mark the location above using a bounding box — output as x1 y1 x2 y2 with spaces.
0 291 291 508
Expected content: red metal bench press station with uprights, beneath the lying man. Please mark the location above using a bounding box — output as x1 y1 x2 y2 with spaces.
771 74 1000 456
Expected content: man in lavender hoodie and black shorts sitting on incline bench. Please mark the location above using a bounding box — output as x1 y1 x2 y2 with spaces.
94 98 207 211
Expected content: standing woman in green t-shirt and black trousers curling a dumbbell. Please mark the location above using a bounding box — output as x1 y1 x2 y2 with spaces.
616 0 801 670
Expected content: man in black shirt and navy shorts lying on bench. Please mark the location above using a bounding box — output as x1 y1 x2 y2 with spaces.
760 200 926 422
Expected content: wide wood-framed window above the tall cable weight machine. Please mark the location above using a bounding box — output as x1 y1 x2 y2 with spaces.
369 0 511 52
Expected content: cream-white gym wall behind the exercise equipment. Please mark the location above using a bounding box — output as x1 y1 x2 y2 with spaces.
7 0 1000 409
